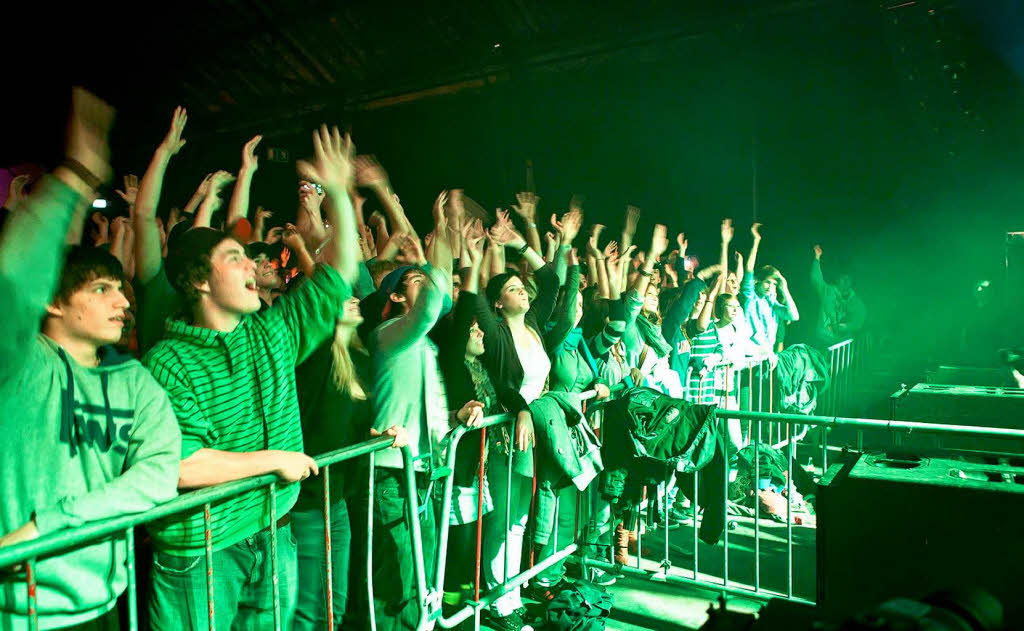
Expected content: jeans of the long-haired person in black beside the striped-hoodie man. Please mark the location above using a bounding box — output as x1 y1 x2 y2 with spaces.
291 499 352 631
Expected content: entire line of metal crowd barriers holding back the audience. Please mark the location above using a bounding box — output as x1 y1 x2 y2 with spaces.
0 340 880 631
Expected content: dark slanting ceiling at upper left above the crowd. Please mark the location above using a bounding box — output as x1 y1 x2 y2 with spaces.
4 0 849 148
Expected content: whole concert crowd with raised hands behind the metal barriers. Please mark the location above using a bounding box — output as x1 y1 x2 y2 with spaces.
0 89 864 631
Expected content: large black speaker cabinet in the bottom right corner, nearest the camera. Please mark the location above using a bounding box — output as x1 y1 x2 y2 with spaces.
817 452 1024 629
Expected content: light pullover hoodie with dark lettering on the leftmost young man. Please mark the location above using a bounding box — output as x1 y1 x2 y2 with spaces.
0 178 181 631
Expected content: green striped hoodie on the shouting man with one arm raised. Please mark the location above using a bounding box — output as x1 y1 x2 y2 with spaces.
143 265 351 555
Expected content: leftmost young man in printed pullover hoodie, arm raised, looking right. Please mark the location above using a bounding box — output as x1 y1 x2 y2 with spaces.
0 90 181 630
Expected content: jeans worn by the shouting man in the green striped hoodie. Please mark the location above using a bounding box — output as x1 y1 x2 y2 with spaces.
148 524 298 631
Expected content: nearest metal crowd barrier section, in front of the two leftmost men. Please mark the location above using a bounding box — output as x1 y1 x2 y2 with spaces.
0 436 407 631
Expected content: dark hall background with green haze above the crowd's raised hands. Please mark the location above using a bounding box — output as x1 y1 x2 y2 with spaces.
0 0 1024 363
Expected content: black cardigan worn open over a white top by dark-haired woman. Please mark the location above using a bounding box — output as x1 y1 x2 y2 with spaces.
462 263 559 414
